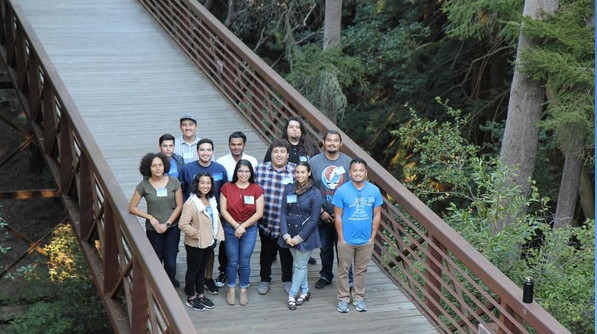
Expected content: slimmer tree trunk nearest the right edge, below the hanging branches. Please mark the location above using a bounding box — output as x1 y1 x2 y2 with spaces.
553 128 584 228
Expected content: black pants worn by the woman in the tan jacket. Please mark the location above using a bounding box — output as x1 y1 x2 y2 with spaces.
184 245 214 297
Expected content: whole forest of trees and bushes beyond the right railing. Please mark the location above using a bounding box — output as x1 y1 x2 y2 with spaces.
204 0 595 333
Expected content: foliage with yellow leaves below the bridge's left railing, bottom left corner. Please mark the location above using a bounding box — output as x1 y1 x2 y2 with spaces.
7 225 111 334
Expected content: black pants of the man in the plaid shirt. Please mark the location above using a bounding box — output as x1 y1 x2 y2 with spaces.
259 229 292 282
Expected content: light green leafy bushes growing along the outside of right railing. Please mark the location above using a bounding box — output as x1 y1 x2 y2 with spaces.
399 105 595 333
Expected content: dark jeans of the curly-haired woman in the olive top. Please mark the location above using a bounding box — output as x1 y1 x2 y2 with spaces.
145 226 180 282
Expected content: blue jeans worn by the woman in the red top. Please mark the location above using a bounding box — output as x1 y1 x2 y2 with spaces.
224 224 257 289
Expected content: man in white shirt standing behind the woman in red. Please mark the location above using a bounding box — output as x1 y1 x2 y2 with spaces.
216 131 258 287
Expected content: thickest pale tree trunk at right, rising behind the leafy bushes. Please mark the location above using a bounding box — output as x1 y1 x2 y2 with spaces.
497 0 558 230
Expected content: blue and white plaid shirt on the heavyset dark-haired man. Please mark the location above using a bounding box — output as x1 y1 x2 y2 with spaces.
255 162 296 239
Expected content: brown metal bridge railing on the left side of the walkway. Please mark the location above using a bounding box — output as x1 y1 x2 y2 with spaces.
0 0 196 333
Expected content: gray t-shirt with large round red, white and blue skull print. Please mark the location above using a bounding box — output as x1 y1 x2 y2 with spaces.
309 153 352 214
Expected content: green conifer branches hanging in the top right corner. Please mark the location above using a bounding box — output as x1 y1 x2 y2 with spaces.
521 0 595 167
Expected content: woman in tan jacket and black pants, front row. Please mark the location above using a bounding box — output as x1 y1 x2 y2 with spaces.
178 172 224 311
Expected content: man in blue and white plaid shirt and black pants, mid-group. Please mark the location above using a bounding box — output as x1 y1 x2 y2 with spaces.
255 138 296 295
